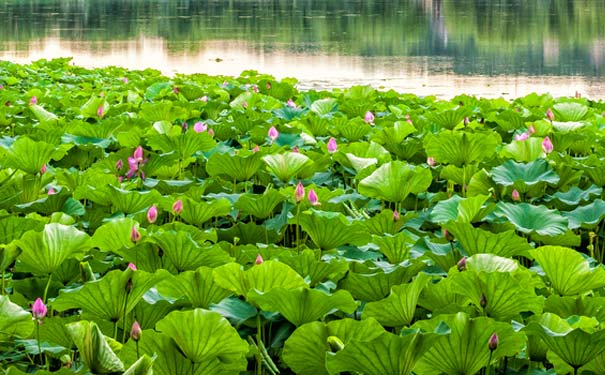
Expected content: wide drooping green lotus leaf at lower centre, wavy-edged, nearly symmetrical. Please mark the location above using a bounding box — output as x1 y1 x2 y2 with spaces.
247 287 357 326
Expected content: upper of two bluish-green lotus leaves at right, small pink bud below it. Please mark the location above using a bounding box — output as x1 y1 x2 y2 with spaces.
491 159 559 192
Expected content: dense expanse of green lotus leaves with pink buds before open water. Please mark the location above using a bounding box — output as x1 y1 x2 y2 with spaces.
0 59 605 375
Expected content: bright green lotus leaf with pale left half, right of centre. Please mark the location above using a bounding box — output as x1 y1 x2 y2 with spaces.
357 161 433 203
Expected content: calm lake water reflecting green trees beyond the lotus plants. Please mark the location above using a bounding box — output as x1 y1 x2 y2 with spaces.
0 0 605 99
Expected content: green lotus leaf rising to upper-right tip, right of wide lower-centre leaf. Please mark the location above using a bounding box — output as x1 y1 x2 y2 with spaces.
362 273 431 327
